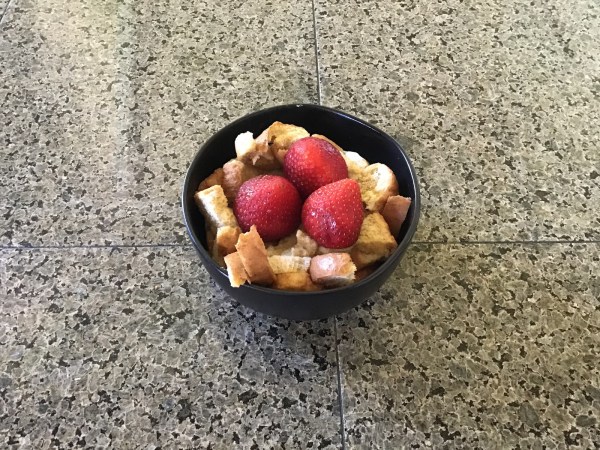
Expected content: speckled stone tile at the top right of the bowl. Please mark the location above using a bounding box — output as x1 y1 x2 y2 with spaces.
315 0 600 241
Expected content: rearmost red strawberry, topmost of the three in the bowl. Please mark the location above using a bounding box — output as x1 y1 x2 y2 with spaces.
283 137 348 198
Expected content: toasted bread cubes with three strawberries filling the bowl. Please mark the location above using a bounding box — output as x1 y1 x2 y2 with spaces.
194 122 411 291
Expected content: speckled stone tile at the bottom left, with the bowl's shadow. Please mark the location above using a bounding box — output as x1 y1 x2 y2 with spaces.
0 248 341 450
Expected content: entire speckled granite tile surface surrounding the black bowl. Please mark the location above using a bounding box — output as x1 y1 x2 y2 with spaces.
0 0 600 450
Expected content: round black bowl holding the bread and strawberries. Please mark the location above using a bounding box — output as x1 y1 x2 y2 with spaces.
182 105 421 320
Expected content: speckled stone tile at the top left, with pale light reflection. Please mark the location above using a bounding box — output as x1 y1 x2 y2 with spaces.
0 0 317 246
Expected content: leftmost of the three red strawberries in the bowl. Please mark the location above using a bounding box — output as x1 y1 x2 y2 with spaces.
233 175 302 241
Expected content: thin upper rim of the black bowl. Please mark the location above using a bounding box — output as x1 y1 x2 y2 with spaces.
180 103 421 297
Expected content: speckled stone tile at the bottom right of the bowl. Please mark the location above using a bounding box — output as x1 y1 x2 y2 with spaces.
337 244 600 449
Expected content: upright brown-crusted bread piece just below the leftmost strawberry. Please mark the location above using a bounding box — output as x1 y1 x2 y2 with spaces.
235 225 275 286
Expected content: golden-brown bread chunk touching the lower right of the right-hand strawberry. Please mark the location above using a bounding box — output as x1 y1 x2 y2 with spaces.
350 212 397 269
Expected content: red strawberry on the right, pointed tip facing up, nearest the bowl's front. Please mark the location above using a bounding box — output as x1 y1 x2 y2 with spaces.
302 178 363 248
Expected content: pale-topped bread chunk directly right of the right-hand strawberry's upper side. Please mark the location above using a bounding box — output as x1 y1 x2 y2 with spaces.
358 163 398 211
